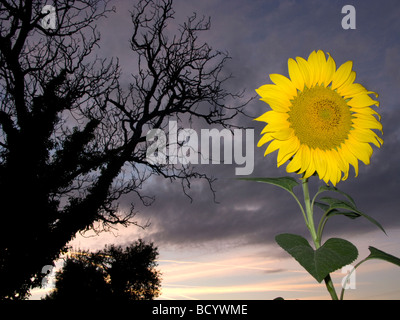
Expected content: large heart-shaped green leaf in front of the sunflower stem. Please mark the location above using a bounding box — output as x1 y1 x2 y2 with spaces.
275 233 358 282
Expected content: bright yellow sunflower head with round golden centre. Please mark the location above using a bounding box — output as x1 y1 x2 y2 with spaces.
255 50 383 186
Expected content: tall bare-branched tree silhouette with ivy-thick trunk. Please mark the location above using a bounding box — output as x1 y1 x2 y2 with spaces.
0 0 245 299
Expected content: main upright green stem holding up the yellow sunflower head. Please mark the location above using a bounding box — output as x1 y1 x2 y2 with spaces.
301 178 339 300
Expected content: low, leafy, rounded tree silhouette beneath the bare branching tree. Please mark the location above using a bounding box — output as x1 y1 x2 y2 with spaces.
45 240 161 301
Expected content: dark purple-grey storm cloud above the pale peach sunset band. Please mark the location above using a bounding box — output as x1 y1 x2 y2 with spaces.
101 0 400 249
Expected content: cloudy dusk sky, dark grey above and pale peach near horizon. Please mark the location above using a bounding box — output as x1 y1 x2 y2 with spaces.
32 0 400 300
